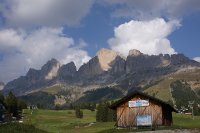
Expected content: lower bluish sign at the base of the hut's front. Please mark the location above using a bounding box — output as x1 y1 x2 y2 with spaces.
136 115 152 126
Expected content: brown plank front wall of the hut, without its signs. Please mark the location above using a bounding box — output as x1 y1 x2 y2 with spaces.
117 96 163 127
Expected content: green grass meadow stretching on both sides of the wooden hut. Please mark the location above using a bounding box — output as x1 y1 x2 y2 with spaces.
20 110 200 133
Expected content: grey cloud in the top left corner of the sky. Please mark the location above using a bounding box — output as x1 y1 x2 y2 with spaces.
0 0 94 27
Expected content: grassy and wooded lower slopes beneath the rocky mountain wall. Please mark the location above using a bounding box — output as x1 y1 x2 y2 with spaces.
15 69 200 113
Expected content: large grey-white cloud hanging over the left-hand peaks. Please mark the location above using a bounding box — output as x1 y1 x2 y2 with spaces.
0 27 90 81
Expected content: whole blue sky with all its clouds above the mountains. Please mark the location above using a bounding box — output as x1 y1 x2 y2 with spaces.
0 0 200 82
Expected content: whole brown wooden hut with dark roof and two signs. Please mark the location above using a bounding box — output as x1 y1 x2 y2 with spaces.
110 91 177 128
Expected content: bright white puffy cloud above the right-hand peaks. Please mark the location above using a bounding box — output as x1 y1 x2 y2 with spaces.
108 18 180 56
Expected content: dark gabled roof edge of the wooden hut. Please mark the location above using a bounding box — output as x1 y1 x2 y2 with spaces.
110 91 178 113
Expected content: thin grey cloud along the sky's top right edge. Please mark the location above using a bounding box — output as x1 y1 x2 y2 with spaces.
101 0 200 20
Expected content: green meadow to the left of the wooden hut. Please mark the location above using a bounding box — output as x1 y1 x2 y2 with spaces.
24 110 114 133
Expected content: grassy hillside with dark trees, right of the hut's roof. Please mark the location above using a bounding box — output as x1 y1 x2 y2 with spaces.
144 69 200 109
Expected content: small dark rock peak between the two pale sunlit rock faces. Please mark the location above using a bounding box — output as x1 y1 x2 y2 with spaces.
58 62 76 80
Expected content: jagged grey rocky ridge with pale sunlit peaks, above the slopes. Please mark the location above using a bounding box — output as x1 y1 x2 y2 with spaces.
3 48 200 95
